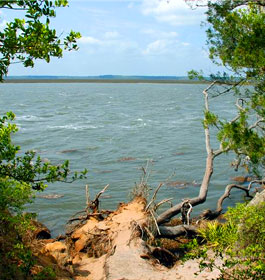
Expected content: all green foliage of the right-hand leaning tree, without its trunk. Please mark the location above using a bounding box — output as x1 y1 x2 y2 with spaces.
186 0 265 176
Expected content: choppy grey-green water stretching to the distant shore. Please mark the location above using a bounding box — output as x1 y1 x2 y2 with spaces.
0 84 241 234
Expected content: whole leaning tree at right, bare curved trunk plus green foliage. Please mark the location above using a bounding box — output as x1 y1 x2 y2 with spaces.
148 0 265 235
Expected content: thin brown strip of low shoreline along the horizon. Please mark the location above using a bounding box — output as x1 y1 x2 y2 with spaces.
3 79 209 84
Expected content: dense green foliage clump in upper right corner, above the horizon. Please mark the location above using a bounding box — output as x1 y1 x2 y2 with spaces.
207 0 265 78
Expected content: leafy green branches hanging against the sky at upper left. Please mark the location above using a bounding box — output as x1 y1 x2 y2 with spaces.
0 0 81 81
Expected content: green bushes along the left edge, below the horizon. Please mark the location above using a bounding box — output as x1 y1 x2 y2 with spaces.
0 112 87 280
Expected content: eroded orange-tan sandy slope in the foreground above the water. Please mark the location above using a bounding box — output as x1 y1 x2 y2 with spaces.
36 198 220 280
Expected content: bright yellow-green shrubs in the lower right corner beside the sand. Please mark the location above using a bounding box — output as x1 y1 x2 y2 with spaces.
183 202 265 280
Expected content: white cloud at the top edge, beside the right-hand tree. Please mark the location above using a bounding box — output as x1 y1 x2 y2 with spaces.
141 0 205 26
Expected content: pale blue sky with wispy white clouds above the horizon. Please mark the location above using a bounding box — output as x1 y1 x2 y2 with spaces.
0 0 220 76
